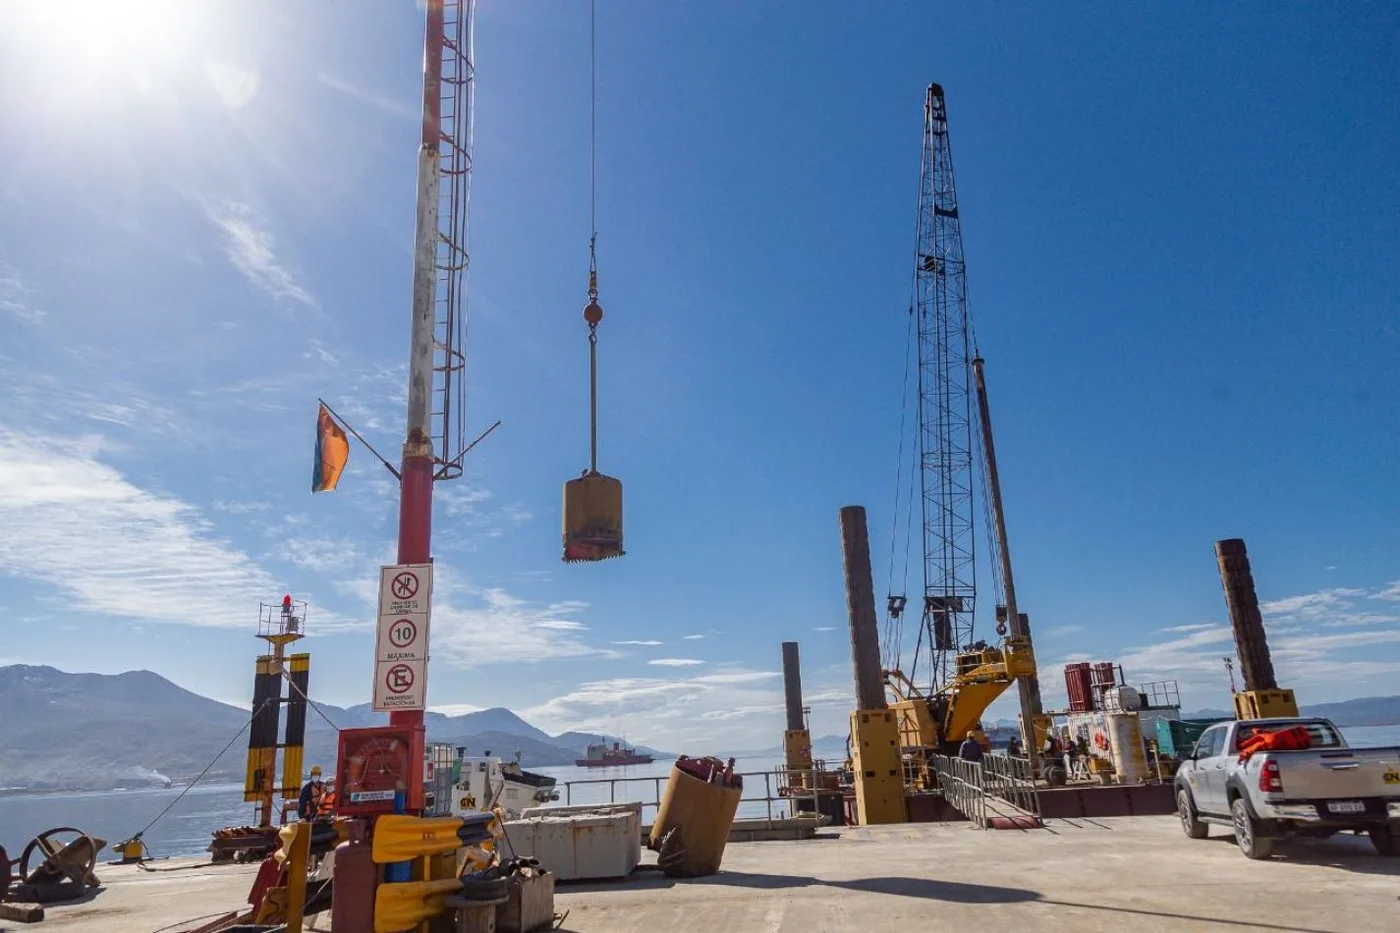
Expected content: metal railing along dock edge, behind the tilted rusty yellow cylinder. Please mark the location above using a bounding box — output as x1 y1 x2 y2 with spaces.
554 768 836 827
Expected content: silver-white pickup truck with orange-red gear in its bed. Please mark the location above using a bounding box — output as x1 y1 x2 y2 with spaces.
1175 719 1400 859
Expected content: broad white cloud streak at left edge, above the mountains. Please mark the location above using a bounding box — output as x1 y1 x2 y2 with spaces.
0 431 309 629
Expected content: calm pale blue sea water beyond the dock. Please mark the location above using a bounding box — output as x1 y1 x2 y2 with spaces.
0 726 1400 857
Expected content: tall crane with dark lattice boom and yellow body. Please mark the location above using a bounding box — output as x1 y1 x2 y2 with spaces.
882 84 1049 787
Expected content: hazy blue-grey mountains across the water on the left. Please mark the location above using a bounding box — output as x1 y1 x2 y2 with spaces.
0 664 675 793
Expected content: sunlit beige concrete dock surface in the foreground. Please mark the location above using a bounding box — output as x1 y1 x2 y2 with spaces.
24 817 1400 933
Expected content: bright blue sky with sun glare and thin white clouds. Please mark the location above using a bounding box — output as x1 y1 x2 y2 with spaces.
0 0 1400 751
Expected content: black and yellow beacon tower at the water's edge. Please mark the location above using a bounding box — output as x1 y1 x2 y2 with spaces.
244 595 311 827
